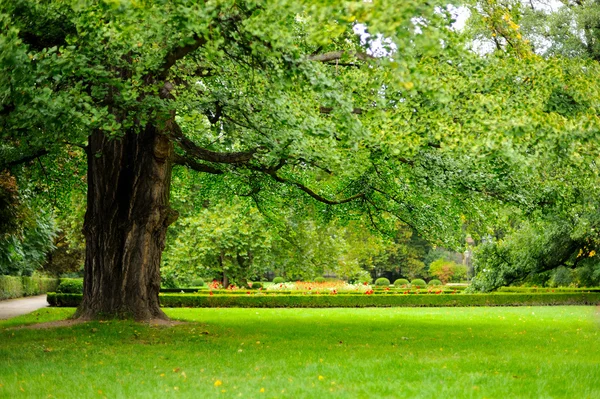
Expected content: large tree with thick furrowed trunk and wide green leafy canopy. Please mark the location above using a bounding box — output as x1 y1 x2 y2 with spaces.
0 0 597 319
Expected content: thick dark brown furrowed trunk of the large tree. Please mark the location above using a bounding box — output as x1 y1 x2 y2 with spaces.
76 125 177 320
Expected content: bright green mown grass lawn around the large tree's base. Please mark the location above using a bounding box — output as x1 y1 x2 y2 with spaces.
0 306 600 398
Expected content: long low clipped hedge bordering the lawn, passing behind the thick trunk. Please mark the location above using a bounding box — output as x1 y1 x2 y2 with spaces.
48 293 600 308
